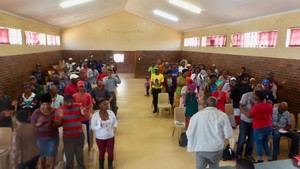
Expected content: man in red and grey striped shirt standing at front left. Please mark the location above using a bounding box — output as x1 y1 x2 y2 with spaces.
54 94 86 169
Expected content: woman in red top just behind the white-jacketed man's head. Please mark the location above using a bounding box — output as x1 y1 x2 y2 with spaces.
212 80 229 112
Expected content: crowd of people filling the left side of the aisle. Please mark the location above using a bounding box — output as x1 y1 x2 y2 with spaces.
0 55 121 169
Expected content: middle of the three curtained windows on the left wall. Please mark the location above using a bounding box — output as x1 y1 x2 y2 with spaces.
25 31 46 45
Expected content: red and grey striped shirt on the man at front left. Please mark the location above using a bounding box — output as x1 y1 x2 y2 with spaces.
54 104 83 138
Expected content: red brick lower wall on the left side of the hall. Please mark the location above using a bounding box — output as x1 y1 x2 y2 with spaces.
0 51 61 98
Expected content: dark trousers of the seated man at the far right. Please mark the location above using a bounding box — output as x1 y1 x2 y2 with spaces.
272 129 299 156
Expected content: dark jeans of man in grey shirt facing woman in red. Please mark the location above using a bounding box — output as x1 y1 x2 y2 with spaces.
236 120 254 156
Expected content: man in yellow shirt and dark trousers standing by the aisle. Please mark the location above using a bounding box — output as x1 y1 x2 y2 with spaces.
151 67 164 113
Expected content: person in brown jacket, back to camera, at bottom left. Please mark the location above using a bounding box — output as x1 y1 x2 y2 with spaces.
10 110 40 169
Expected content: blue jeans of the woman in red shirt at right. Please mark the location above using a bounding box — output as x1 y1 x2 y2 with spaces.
253 126 272 160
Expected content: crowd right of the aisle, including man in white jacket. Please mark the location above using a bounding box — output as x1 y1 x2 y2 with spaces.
145 60 299 169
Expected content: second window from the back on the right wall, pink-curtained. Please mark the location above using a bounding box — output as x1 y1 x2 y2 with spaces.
202 35 226 47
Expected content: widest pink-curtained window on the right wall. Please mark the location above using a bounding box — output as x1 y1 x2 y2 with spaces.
230 30 278 48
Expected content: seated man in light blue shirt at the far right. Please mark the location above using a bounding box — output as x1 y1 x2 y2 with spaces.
272 102 299 160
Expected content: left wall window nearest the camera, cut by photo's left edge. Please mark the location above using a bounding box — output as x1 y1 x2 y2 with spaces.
0 27 22 45
